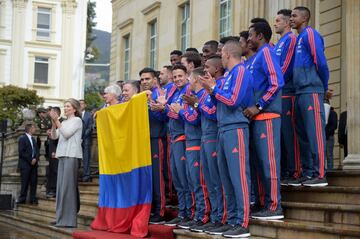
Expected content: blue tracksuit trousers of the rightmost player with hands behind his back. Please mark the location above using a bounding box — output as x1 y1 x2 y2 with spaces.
295 93 326 178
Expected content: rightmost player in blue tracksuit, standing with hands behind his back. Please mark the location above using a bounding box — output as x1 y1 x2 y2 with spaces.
289 7 329 187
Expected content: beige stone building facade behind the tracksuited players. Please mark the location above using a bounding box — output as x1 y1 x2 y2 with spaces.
110 0 360 168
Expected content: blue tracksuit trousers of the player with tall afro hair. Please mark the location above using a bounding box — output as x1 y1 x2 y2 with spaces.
251 117 281 211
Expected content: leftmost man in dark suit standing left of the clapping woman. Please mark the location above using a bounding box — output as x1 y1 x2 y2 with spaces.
17 124 39 204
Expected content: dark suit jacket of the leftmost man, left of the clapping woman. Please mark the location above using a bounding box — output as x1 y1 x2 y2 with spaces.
18 134 40 169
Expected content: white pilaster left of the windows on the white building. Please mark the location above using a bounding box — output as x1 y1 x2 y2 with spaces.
11 0 28 85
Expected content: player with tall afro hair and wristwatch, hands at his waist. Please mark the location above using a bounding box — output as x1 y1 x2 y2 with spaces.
248 22 284 220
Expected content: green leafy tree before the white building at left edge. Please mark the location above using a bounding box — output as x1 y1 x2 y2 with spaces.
0 85 44 127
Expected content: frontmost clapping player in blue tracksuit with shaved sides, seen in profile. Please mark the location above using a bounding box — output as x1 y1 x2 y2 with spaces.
202 41 252 237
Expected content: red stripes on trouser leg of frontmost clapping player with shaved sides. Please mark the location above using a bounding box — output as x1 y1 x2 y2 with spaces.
237 129 250 228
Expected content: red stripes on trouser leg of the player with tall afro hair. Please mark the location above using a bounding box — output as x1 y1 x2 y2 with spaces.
266 120 278 211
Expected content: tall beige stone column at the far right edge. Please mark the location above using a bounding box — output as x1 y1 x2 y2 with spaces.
343 0 360 169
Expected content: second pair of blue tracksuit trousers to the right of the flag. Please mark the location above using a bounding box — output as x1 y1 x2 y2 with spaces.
170 136 192 218
